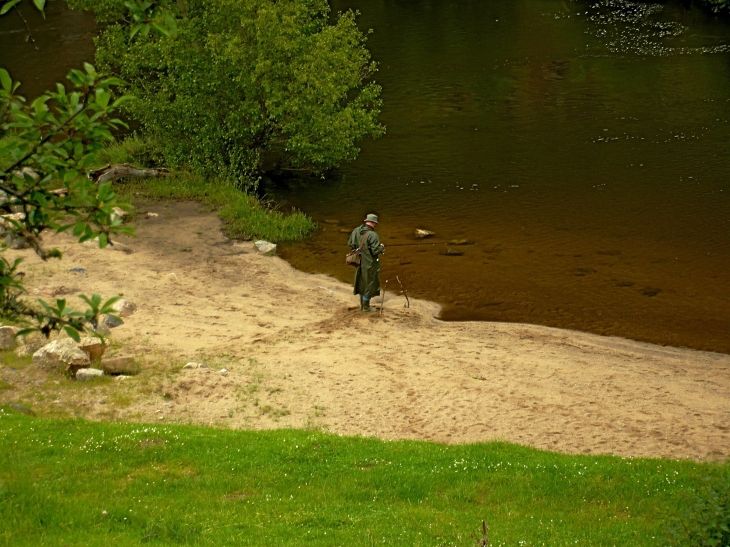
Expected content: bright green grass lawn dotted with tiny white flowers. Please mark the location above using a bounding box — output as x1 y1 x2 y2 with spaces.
0 409 727 547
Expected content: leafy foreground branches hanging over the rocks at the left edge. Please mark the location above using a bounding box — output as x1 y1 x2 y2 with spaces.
0 63 131 340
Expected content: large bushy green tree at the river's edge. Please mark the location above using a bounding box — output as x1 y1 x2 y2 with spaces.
71 0 384 187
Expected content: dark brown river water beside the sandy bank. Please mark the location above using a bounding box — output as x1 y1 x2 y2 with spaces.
0 0 730 353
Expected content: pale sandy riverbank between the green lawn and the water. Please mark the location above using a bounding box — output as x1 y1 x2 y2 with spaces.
0 203 730 459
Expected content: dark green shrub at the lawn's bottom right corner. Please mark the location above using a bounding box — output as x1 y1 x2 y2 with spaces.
671 469 730 547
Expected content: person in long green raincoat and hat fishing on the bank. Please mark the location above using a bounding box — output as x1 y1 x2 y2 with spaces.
347 214 385 312
